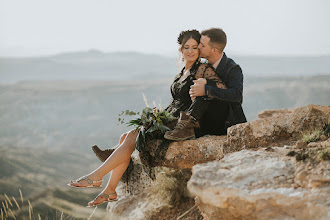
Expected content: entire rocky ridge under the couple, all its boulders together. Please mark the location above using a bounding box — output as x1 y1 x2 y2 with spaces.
108 105 330 219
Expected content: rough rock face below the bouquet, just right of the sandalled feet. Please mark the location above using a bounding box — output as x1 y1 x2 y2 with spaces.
108 168 201 220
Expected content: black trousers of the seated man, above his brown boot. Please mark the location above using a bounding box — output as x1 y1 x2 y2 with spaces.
187 97 228 137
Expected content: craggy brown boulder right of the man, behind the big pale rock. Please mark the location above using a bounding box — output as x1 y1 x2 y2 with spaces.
227 105 330 150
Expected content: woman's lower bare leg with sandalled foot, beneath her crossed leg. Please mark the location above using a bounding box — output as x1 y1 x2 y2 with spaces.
88 159 130 206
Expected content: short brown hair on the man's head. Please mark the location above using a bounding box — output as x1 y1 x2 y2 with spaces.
201 28 227 52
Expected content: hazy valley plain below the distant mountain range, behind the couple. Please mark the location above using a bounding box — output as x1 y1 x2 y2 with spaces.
0 75 330 153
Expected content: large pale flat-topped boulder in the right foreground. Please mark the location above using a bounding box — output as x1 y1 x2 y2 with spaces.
188 150 330 219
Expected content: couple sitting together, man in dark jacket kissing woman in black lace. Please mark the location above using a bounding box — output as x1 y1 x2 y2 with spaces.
68 28 246 207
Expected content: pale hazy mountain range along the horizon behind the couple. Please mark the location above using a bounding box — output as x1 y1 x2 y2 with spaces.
0 50 330 84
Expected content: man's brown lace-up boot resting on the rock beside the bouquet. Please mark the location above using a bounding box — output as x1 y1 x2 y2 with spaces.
164 112 199 141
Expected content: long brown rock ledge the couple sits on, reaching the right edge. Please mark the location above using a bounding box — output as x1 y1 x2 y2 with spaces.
159 105 330 169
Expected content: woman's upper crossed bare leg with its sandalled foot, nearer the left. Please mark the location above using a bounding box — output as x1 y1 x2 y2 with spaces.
70 130 139 186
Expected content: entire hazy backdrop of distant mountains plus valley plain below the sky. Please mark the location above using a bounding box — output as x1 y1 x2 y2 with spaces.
0 50 330 152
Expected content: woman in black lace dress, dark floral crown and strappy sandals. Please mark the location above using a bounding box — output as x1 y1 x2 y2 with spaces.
68 30 226 207
